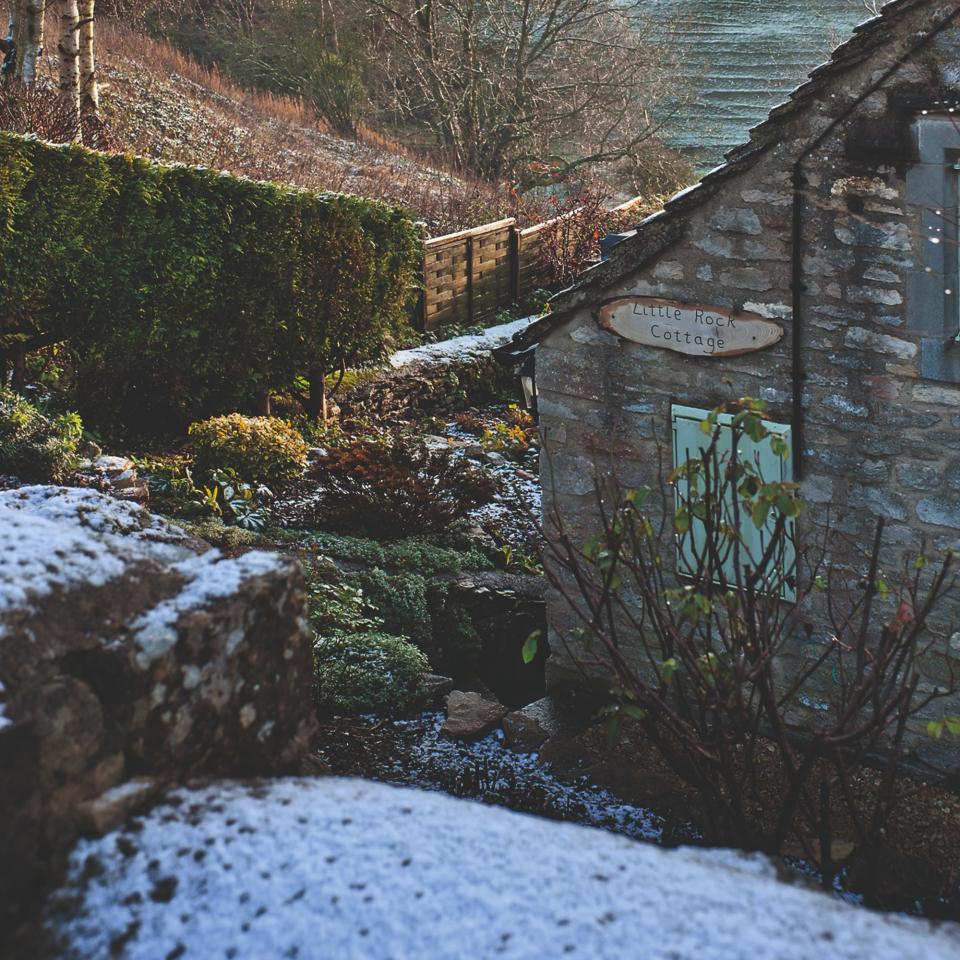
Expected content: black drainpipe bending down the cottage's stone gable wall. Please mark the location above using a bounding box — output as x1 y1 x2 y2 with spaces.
791 7 960 480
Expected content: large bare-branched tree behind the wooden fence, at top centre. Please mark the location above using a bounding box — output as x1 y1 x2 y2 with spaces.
365 0 678 178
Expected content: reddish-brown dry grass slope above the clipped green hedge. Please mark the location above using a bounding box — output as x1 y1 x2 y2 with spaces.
0 8 680 236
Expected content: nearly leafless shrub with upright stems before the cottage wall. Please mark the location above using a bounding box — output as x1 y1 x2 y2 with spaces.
548 400 960 900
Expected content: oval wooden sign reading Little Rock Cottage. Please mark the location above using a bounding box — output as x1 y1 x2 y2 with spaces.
597 297 783 357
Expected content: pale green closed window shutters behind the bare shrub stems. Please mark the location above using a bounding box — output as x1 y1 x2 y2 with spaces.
672 405 796 600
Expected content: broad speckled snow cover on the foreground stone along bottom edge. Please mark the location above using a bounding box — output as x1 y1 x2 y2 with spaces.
47 778 960 960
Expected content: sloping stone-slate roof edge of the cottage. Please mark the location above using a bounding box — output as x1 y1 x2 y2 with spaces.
517 0 960 346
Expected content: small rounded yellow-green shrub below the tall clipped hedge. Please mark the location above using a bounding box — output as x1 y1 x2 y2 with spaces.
188 413 307 486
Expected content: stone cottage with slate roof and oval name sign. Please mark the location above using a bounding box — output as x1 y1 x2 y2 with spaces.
525 0 960 765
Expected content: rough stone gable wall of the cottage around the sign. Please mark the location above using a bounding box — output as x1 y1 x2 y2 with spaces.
537 5 960 768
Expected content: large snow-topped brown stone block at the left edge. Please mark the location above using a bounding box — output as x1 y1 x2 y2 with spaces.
0 487 313 940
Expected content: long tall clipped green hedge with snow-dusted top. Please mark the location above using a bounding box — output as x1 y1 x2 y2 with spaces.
0 133 421 436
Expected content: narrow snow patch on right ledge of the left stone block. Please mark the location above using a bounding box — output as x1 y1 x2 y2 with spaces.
130 550 277 669
